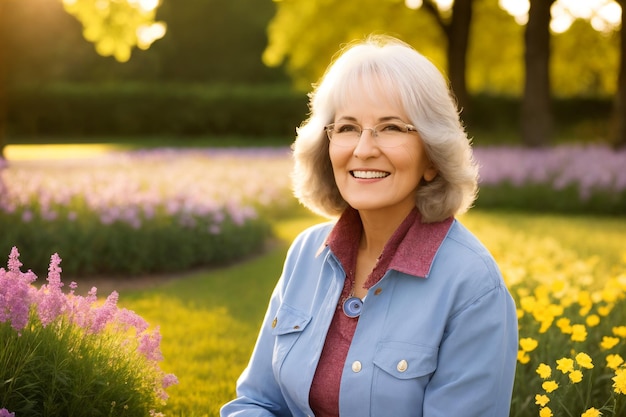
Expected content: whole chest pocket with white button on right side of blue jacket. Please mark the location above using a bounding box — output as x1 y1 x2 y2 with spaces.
371 342 438 417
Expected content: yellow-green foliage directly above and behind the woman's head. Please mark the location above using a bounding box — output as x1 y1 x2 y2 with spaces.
263 0 445 91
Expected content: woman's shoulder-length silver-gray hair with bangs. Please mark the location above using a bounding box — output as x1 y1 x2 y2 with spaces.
292 35 478 222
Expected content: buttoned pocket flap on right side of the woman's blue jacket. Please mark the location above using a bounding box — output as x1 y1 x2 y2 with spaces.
374 342 439 379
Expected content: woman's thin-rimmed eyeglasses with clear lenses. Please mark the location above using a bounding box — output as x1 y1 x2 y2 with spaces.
324 121 417 148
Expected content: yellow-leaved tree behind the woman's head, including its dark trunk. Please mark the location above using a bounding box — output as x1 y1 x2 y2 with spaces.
264 0 474 111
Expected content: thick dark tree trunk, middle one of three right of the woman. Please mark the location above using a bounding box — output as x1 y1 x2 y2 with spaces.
521 0 555 147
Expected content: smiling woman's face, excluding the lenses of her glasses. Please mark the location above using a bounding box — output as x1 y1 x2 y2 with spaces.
329 88 437 216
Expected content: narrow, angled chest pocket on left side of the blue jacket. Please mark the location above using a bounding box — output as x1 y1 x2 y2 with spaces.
271 304 311 377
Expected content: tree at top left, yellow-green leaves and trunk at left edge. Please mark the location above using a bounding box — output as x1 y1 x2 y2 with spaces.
0 0 165 158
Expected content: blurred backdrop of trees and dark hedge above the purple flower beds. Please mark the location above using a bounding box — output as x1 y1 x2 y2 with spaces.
0 0 626 151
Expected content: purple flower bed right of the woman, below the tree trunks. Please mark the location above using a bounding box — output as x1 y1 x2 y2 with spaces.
475 145 626 215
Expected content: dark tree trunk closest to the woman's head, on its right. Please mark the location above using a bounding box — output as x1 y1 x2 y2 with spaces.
446 0 473 119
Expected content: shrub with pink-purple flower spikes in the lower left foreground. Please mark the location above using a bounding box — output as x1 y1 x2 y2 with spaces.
0 248 177 417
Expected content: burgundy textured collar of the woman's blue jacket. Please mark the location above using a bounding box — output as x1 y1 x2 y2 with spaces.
326 207 454 278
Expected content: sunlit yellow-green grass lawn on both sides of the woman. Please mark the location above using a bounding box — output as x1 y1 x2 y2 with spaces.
112 211 626 416
